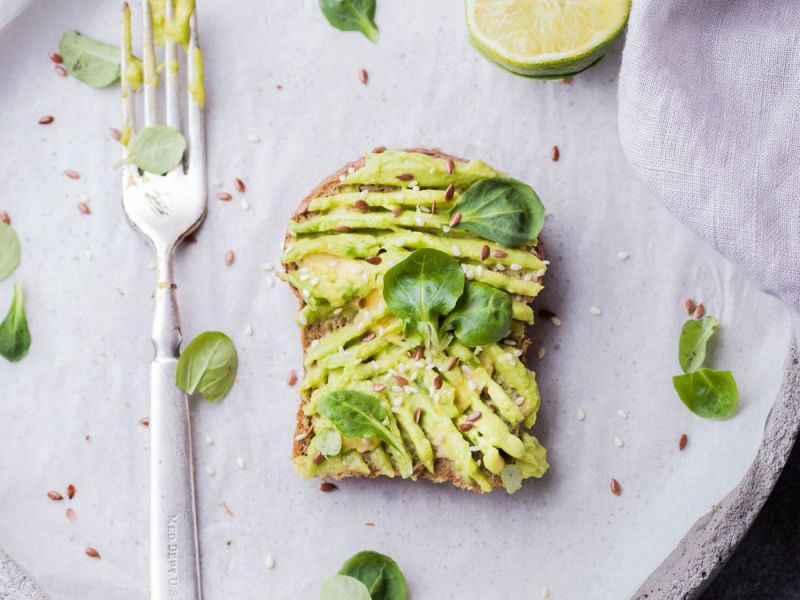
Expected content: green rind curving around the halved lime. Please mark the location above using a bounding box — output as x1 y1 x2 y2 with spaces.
465 0 631 79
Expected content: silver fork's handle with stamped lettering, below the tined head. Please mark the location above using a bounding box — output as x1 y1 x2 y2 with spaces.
150 256 201 600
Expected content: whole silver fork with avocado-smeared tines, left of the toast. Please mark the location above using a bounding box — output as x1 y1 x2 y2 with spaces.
121 0 208 600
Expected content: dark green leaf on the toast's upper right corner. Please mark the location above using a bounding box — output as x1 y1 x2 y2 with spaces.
451 177 544 247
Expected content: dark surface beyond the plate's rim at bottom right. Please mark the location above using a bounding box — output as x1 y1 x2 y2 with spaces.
699 436 800 600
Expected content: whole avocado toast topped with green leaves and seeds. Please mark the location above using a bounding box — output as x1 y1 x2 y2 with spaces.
281 148 547 492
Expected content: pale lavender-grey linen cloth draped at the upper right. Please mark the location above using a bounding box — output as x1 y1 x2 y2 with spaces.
619 0 800 315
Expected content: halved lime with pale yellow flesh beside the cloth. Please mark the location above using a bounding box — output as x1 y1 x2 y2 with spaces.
466 0 631 78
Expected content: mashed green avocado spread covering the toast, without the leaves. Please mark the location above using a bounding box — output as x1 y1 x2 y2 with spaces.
281 151 548 492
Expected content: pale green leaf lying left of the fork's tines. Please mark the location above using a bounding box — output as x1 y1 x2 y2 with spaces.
58 31 121 88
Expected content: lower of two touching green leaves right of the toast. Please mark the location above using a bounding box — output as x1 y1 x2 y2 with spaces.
672 368 739 420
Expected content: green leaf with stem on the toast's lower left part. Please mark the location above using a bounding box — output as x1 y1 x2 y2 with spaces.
318 390 406 453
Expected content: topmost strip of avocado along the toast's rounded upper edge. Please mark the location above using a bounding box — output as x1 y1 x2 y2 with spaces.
344 150 502 189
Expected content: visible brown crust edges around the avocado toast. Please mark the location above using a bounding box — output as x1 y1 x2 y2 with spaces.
283 148 544 493
